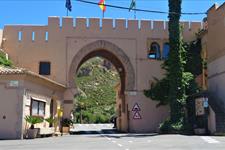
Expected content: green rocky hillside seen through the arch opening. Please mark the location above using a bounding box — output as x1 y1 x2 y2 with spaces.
75 57 119 123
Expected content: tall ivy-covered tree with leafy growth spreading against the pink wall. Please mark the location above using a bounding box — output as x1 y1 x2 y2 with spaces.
144 0 201 132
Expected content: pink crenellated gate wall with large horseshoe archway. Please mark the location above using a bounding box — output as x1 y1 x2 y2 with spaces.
1 17 201 132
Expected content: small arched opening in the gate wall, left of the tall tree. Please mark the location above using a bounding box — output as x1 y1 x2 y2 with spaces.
148 42 161 59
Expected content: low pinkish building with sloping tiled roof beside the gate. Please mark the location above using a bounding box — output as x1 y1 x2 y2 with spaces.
0 67 66 139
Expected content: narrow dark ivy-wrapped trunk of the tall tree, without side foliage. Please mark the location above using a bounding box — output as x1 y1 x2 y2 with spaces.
164 0 186 123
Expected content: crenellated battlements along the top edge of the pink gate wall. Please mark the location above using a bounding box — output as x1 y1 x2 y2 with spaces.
4 17 202 41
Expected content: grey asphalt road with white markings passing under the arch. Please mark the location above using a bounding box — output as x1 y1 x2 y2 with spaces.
0 124 225 150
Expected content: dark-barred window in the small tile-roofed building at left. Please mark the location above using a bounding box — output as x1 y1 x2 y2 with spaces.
30 99 45 116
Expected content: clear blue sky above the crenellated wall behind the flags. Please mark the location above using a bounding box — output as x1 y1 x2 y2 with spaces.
0 0 224 28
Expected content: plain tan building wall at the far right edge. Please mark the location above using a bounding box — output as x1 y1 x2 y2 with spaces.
202 3 225 133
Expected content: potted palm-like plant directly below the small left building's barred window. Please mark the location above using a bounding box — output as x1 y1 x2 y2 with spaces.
25 116 44 139
